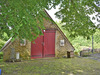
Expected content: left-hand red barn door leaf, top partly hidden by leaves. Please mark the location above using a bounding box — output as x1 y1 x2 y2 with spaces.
31 36 43 58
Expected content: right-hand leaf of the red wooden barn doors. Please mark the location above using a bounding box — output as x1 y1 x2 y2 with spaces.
44 30 55 57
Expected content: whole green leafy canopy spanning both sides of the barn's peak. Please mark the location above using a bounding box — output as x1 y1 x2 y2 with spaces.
0 0 100 41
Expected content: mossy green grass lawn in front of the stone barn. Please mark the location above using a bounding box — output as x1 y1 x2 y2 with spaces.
0 58 100 75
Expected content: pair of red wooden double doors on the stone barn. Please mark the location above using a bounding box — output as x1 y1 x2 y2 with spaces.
31 30 55 58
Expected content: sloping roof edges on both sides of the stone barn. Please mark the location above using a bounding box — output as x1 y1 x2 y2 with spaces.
1 10 75 51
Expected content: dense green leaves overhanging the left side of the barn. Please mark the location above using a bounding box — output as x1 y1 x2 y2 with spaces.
0 0 54 41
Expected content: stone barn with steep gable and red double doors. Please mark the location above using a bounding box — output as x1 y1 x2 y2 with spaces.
1 12 74 61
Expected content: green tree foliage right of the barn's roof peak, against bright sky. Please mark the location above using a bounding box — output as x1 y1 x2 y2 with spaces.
56 0 100 37
